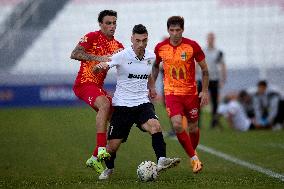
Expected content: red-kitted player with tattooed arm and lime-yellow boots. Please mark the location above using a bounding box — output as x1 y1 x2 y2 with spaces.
71 10 123 173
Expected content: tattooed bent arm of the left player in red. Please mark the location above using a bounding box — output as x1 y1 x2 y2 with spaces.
70 45 110 62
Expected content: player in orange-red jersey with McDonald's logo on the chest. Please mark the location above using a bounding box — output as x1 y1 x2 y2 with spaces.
150 16 208 173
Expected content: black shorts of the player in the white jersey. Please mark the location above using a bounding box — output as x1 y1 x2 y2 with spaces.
108 103 158 142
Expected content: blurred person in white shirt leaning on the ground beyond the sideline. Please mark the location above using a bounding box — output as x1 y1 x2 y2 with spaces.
218 94 258 131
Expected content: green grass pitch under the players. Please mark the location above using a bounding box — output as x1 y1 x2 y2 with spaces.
0 105 284 189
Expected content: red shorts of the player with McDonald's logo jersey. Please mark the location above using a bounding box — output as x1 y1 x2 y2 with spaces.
165 95 200 122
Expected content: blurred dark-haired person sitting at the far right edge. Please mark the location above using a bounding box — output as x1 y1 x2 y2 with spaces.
253 80 283 129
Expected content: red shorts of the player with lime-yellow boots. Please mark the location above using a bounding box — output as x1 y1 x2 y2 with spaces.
73 85 111 111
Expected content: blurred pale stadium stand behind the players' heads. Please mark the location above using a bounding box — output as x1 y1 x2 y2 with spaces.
0 0 284 106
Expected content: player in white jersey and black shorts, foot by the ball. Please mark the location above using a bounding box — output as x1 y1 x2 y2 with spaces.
95 24 180 179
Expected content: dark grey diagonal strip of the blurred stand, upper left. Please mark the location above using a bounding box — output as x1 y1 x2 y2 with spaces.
0 0 68 70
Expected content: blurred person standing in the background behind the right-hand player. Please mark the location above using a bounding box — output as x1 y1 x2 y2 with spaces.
198 32 227 128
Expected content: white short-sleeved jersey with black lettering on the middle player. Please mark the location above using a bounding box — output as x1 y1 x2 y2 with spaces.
108 47 156 107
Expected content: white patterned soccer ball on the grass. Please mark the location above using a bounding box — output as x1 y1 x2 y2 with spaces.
137 161 158 181
